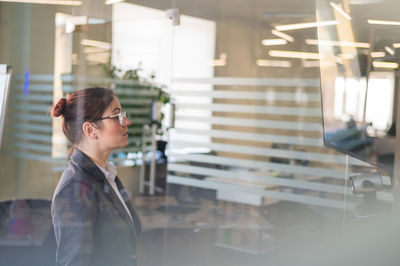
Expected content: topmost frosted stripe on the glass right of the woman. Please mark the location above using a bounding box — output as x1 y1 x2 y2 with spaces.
172 77 320 87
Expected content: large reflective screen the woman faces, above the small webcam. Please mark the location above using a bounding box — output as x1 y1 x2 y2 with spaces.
318 1 400 176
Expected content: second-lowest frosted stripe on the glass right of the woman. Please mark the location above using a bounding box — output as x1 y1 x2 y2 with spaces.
168 163 351 195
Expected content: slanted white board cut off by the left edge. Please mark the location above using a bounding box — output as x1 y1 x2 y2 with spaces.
0 64 11 147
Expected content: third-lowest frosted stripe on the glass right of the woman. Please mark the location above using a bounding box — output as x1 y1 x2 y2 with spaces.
168 151 356 179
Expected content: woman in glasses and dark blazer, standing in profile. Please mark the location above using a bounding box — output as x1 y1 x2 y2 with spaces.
51 88 141 266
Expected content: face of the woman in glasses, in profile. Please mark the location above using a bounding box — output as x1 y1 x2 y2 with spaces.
97 97 131 150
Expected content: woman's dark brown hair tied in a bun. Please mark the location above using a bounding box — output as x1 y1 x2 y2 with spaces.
51 87 115 144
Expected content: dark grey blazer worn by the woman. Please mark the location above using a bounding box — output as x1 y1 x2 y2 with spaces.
51 149 141 266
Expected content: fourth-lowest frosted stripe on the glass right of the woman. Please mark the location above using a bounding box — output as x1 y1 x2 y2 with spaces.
169 140 369 166
